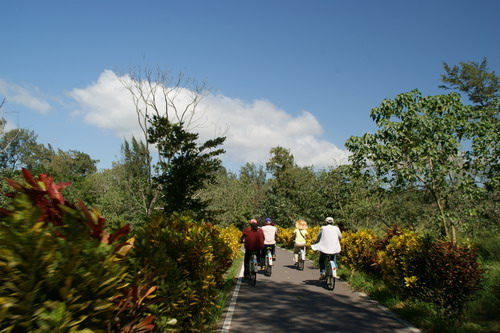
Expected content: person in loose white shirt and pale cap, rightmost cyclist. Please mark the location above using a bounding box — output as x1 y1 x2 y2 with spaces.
311 217 342 280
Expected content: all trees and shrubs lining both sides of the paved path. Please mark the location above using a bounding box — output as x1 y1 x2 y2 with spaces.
0 59 500 332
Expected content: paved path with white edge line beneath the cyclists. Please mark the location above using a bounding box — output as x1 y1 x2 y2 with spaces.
218 245 419 333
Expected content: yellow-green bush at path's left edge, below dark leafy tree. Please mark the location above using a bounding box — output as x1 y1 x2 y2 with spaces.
132 214 234 330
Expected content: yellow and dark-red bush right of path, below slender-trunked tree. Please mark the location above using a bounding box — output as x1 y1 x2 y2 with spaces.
378 231 483 317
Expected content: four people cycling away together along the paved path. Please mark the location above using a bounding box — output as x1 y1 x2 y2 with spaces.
241 217 342 280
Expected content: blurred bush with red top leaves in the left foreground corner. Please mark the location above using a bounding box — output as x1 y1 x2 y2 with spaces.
0 170 152 332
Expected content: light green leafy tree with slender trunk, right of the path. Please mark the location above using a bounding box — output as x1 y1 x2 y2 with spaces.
346 90 476 239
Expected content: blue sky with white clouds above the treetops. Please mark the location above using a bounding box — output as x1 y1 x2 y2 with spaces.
0 0 500 171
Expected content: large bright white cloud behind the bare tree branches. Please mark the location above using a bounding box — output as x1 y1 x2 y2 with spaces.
69 71 348 167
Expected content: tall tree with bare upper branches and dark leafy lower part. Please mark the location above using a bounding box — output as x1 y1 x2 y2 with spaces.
121 68 224 216
